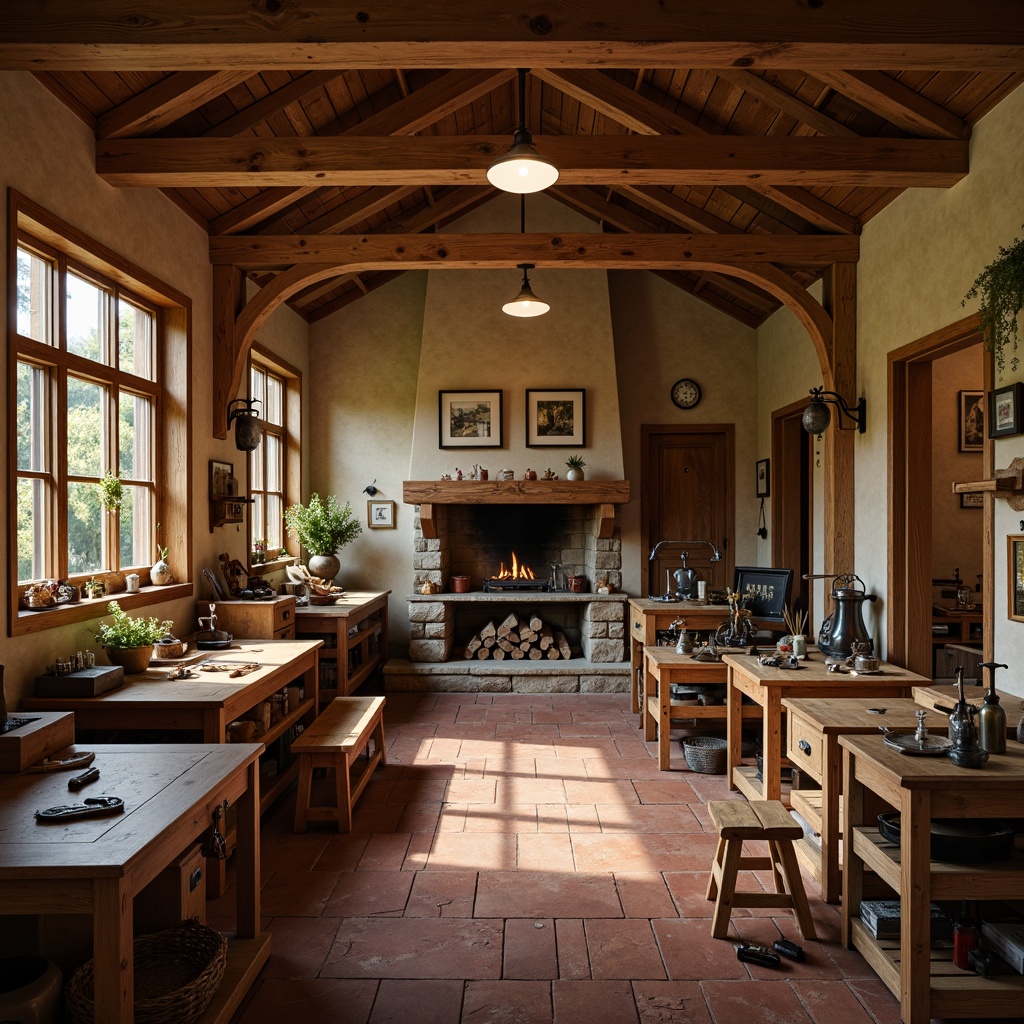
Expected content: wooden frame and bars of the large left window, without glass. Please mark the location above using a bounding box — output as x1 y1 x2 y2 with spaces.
7 188 194 636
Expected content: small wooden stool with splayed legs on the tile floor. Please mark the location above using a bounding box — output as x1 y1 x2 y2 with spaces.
708 800 816 939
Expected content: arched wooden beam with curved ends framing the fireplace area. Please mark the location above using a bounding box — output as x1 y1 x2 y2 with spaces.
213 233 833 436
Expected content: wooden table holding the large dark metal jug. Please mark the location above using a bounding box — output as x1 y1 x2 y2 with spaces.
723 651 929 800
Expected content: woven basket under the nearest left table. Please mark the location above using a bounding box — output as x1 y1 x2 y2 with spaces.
65 921 227 1024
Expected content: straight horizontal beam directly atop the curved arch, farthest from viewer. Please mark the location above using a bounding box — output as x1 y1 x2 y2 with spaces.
210 229 860 269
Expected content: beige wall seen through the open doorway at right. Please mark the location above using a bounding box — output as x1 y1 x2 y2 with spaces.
932 344 983 589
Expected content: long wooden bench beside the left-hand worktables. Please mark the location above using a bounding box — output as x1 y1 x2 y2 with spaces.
292 697 387 833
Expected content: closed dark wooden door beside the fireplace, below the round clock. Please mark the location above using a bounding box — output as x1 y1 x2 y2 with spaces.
640 424 735 596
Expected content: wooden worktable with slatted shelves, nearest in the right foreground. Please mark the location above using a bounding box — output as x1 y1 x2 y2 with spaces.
840 735 1024 1024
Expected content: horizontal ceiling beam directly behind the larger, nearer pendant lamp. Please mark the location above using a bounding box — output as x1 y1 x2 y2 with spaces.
96 135 968 188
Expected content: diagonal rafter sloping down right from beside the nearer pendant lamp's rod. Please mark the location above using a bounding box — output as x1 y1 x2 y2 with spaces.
535 70 860 234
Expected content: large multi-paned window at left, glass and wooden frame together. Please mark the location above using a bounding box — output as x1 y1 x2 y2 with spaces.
8 191 190 633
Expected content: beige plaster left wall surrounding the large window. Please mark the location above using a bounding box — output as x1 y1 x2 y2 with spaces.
0 72 305 701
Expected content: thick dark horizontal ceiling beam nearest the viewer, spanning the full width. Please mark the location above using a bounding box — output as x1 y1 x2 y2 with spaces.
0 0 1024 71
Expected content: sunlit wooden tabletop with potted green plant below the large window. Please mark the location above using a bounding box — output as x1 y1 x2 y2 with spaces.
20 640 322 743
